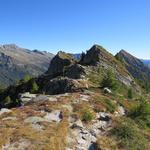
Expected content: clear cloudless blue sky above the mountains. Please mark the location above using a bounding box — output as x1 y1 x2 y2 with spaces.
0 0 150 59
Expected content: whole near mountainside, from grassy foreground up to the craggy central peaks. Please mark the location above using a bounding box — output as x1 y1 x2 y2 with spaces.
0 45 150 150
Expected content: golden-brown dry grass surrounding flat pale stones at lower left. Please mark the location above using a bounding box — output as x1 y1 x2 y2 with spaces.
0 99 69 150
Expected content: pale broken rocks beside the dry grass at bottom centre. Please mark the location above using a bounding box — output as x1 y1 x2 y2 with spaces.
68 112 112 150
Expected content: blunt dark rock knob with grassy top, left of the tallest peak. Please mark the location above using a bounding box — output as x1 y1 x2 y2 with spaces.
46 51 75 78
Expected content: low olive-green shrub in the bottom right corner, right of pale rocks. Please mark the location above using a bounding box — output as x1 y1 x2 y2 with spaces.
111 118 148 150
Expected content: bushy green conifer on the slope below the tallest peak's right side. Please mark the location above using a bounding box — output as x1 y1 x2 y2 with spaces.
100 70 117 90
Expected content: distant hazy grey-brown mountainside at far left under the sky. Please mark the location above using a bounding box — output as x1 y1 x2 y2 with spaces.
0 44 53 86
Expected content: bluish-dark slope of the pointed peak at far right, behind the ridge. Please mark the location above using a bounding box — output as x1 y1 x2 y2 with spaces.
116 50 150 81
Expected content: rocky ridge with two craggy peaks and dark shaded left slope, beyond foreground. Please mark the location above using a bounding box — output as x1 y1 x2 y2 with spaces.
0 45 141 106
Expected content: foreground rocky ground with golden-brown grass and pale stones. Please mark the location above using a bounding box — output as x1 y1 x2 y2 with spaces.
0 91 125 150
